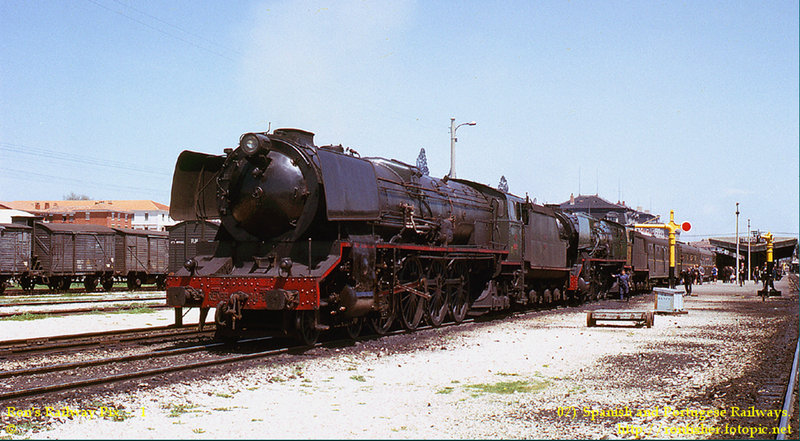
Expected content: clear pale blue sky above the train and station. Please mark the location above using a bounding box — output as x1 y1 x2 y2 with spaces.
0 0 800 240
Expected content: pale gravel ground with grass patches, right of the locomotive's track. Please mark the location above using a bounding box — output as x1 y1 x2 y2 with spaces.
0 283 798 439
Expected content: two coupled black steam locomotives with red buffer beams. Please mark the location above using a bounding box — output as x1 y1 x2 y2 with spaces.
167 125 712 344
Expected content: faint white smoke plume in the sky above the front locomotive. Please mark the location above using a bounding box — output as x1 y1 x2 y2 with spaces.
236 0 414 128
